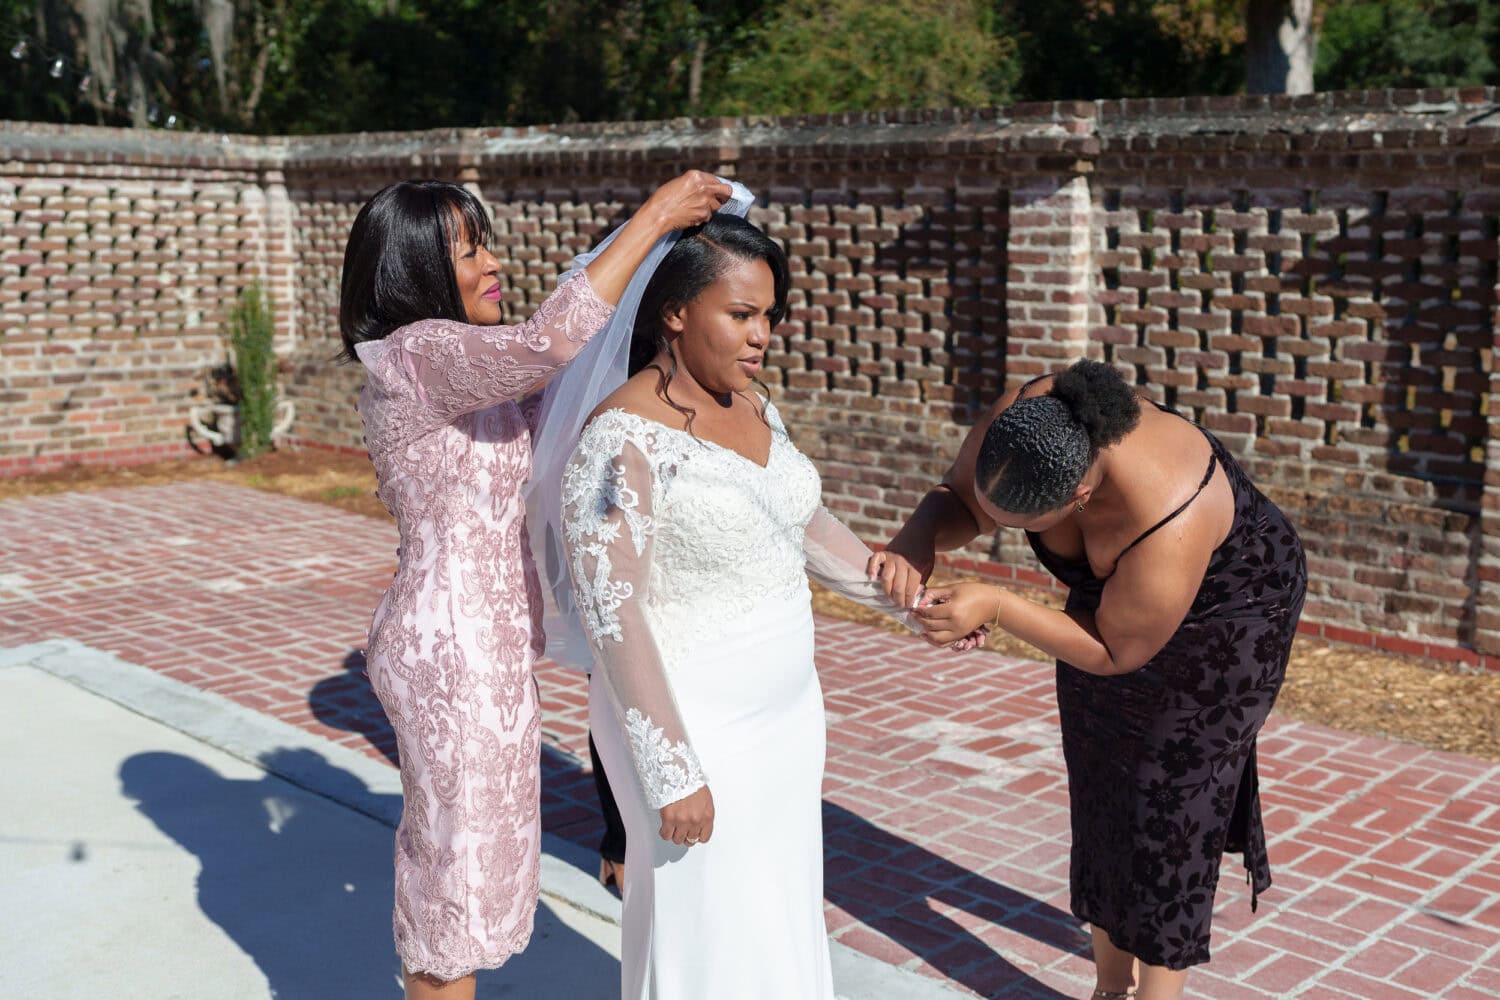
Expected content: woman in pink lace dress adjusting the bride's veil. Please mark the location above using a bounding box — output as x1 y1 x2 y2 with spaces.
339 171 729 997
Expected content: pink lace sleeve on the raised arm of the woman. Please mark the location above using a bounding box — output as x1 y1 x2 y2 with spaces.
392 271 614 423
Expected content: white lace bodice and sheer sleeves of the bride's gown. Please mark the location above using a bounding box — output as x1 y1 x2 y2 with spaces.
563 403 909 808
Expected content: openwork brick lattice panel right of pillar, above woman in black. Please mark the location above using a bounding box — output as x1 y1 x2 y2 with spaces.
1094 189 1497 491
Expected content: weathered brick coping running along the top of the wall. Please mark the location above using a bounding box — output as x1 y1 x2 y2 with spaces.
0 87 1500 171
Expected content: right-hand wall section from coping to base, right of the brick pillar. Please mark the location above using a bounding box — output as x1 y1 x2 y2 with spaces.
1091 91 1500 651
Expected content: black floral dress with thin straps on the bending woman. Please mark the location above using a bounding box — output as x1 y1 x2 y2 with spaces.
1028 407 1307 969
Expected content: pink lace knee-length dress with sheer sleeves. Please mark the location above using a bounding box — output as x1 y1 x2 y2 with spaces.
357 274 612 979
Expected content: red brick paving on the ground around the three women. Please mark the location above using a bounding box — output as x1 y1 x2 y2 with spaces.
0 483 1500 1000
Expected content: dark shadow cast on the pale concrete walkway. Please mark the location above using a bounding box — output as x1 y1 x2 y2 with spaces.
120 750 620 999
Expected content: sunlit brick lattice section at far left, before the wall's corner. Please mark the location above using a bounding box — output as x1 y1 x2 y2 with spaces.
0 163 264 471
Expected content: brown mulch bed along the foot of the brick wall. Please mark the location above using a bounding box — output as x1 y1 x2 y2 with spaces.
0 450 1500 762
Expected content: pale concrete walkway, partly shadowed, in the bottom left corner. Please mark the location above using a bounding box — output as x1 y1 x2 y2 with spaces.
0 645 620 1000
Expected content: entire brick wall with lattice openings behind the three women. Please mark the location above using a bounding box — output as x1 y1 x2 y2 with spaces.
0 90 1500 660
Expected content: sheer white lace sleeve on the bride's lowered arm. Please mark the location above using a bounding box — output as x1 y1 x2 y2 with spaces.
563 425 708 808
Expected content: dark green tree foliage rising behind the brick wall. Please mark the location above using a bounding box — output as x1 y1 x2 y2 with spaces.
0 0 1500 133
